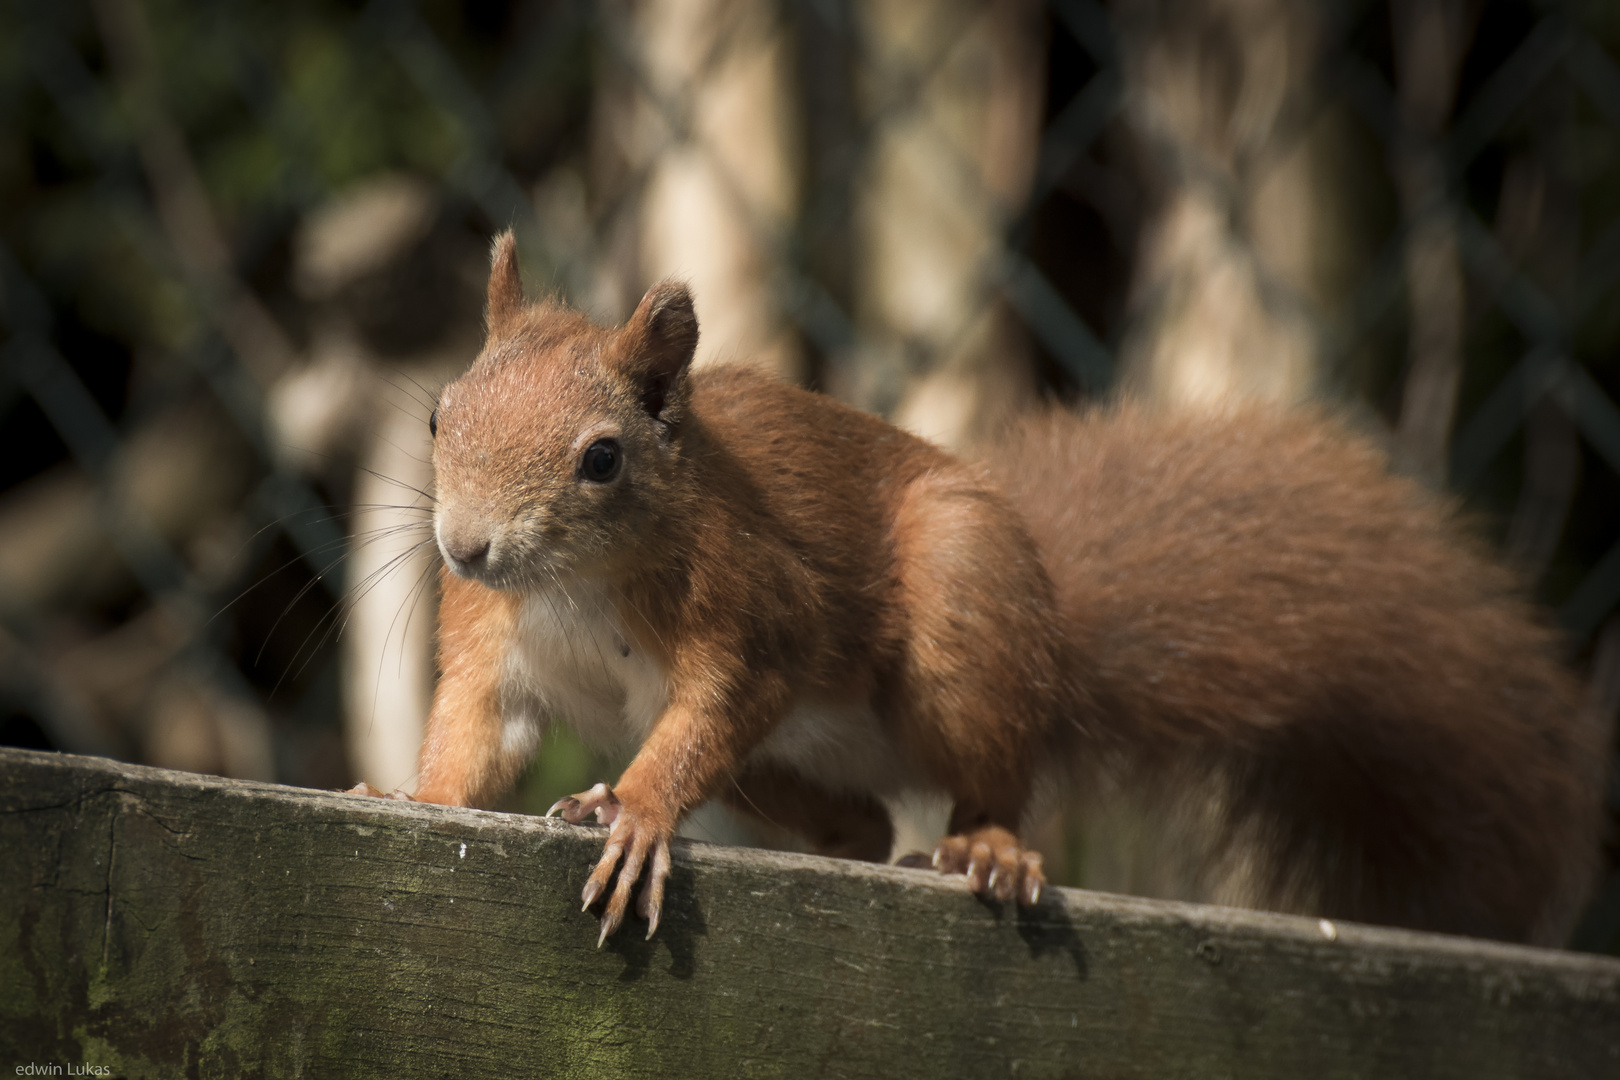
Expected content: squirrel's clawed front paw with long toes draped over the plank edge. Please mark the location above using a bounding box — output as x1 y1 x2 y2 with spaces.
546 784 676 949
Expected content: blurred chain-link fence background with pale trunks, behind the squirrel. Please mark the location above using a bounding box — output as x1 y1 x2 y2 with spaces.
0 0 1620 944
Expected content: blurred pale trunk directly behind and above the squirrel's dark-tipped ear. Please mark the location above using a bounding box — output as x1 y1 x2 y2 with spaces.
593 0 804 379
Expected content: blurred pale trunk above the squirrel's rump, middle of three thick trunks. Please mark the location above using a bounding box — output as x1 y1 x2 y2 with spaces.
855 0 1045 449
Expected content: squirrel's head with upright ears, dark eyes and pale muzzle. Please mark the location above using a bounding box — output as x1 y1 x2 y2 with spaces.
429 232 698 589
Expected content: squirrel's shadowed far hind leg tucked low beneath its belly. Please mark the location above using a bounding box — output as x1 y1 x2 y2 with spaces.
719 764 894 863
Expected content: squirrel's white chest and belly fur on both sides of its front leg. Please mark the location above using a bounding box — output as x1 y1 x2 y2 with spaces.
502 580 923 797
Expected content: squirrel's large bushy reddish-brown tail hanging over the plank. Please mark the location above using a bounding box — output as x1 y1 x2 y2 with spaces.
983 402 1604 944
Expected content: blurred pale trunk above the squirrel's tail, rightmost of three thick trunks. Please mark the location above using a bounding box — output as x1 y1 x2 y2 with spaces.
1115 0 1356 405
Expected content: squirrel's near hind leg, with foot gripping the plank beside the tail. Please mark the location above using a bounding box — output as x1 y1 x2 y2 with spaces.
888 470 1069 905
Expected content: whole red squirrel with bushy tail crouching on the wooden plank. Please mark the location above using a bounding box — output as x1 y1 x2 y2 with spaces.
355 233 1601 941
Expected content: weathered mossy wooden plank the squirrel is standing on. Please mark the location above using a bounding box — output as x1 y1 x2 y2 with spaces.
0 750 1620 1080
